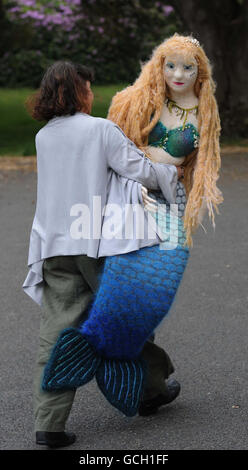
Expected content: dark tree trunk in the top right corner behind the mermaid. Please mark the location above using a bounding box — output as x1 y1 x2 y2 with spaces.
170 0 248 138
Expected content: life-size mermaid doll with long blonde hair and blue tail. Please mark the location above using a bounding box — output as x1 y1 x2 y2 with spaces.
42 34 222 416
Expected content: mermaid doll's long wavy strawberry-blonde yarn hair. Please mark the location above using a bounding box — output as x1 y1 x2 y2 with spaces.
108 33 223 246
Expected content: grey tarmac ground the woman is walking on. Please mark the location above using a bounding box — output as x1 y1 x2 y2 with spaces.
0 153 248 450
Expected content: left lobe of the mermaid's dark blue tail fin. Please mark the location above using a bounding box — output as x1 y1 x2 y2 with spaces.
42 328 101 391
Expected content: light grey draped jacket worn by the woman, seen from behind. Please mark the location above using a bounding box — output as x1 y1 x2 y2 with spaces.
23 113 177 305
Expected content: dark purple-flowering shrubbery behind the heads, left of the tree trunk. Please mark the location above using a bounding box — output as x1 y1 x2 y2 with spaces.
0 0 178 87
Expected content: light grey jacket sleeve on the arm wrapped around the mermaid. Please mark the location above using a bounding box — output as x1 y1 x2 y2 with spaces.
104 122 178 203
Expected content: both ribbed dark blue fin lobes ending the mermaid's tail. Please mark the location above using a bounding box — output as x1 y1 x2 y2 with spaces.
42 328 146 416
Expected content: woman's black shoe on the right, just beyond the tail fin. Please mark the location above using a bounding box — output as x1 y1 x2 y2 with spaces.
139 379 181 416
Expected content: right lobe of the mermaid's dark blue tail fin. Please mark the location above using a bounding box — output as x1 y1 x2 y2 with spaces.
96 359 146 416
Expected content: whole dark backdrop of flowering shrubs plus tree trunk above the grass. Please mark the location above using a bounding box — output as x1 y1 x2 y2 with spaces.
0 0 248 138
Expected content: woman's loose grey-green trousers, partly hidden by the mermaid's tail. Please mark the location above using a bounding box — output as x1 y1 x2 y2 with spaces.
34 255 174 432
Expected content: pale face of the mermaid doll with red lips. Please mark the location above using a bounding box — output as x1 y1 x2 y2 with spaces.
164 52 198 93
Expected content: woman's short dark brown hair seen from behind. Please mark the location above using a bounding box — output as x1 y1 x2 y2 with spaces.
26 61 94 121
